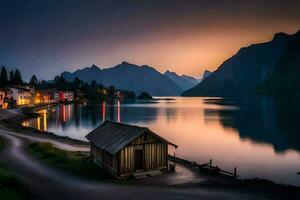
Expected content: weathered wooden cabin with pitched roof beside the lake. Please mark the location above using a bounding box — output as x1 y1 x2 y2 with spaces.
86 121 177 179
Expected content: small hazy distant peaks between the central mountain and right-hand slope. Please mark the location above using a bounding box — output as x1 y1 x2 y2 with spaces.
164 71 198 91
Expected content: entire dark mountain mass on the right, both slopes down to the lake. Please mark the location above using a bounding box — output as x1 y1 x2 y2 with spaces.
182 29 300 97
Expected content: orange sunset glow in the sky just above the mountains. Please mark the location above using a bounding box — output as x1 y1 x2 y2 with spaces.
83 26 300 78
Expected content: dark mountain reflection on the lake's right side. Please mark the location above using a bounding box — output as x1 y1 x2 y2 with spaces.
204 97 300 152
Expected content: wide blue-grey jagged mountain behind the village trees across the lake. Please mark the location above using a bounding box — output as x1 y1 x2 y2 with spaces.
61 62 182 96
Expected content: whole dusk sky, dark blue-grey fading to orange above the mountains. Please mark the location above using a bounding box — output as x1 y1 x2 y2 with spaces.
0 0 300 80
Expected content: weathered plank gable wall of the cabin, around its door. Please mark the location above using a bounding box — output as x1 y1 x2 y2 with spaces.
118 134 168 174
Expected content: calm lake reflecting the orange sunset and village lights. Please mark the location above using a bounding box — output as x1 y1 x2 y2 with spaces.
23 97 300 185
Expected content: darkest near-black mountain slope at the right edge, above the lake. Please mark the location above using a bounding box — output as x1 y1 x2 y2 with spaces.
258 31 300 95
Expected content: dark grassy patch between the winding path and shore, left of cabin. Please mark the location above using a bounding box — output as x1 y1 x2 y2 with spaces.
26 142 110 180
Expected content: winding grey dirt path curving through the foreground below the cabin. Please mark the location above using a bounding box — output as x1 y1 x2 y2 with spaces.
0 130 266 200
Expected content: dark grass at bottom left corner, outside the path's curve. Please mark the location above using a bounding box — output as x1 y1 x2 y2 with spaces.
0 138 30 200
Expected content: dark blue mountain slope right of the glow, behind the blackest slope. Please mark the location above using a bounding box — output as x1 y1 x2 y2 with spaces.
182 30 292 97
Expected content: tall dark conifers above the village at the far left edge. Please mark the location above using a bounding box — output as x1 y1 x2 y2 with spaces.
0 66 24 88
